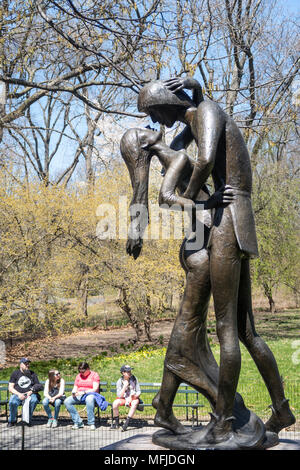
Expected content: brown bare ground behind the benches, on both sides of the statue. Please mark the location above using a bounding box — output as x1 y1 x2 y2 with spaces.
0 309 299 367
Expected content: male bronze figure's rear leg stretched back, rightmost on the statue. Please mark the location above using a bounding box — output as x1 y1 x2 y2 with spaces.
238 259 295 433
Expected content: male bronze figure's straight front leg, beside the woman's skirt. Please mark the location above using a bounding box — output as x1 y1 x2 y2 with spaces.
210 208 241 441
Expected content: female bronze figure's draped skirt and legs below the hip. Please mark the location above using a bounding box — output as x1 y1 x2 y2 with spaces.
153 239 218 434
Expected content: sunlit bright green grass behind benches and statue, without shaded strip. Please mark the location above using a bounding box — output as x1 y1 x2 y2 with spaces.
0 339 300 418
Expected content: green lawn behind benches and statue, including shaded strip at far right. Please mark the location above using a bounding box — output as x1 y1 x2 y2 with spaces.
0 309 300 418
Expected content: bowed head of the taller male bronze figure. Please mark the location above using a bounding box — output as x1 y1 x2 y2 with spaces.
138 80 195 127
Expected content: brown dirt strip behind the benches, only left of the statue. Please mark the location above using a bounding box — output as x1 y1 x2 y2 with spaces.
5 320 173 367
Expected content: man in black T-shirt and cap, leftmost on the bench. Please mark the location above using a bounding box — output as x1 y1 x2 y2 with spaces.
8 357 43 427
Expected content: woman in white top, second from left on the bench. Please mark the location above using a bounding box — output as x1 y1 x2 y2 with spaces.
43 370 66 428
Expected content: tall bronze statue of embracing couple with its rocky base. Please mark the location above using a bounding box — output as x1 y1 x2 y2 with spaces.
121 78 295 449
